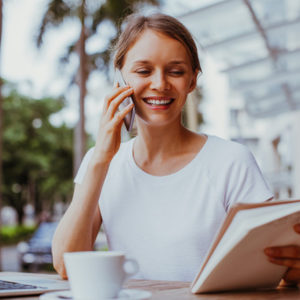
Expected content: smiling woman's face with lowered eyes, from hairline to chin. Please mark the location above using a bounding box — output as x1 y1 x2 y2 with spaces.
122 29 197 126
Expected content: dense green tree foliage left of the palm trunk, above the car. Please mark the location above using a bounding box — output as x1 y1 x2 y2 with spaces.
3 91 73 223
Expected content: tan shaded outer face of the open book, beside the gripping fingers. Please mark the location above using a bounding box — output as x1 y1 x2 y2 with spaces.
198 212 300 292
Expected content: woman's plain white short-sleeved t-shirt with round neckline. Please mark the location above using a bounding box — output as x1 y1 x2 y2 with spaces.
75 136 273 281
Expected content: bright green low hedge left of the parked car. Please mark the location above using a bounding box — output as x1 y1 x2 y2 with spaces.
0 226 36 245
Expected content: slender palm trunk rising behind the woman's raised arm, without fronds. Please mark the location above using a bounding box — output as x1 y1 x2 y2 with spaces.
74 0 87 173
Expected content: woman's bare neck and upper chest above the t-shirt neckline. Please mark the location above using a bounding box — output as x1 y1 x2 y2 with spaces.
133 120 206 176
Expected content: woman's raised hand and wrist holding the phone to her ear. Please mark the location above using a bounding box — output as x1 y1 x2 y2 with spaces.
94 86 134 163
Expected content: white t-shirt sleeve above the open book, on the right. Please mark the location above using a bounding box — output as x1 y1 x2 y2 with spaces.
224 147 273 211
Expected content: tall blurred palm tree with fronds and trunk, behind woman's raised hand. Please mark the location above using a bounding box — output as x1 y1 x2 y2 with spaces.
37 0 160 171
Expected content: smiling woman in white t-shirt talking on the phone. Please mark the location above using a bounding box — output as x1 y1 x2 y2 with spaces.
53 14 298 281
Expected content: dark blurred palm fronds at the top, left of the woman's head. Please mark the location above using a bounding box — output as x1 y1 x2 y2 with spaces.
36 0 163 75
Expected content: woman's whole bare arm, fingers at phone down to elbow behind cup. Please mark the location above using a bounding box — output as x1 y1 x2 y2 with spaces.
52 87 133 278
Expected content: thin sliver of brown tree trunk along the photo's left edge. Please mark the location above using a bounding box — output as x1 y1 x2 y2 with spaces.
0 0 3 271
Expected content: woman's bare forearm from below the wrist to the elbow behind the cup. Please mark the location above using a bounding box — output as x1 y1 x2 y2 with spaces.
52 161 109 277
